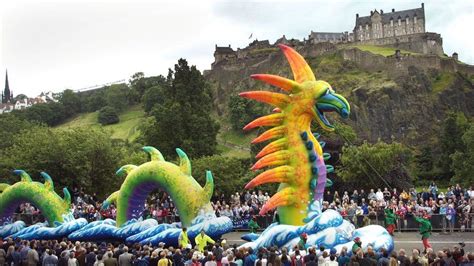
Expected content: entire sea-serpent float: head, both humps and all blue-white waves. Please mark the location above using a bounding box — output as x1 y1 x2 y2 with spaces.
0 45 393 254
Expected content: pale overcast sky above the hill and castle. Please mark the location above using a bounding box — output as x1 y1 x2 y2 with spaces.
0 0 474 96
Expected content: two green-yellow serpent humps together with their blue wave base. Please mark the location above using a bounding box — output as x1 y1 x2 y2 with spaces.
0 149 232 245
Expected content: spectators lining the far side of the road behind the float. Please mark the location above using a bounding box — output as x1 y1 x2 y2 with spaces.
13 183 474 230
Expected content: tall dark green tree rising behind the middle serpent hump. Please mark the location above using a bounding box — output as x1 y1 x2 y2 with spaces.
142 59 219 158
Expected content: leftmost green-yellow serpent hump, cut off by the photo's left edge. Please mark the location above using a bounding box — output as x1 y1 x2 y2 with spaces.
0 170 71 226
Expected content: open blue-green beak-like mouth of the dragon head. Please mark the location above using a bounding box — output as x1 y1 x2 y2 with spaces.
314 93 350 131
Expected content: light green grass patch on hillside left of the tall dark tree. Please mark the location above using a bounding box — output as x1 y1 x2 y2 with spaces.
57 105 145 141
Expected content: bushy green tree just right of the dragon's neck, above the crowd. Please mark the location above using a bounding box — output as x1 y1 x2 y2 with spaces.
336 141 412 188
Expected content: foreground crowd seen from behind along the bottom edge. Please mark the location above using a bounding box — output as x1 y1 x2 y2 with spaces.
0 238 474 266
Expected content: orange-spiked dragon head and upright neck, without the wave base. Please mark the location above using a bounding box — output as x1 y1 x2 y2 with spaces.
240 45 350 225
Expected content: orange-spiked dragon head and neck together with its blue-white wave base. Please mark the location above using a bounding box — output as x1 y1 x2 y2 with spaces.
240 45 393 250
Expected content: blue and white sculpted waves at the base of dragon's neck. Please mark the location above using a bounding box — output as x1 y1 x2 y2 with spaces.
241 210 394 252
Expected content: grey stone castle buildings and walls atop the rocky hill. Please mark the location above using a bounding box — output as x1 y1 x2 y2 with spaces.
212 3 446 67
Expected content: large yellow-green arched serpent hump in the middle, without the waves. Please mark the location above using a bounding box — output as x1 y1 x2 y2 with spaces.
104 146 214 226
